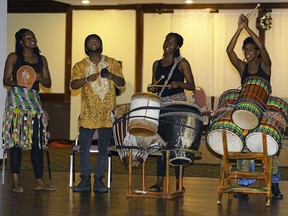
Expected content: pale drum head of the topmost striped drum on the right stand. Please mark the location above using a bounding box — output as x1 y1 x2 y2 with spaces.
232 110 259 130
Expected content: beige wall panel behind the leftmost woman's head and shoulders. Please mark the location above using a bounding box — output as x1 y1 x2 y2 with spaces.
7 13 66 93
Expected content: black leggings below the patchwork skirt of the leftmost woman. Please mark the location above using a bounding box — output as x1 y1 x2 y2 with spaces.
10 118 43 179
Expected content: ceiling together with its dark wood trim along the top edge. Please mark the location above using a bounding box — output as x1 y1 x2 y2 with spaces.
7 0 288 13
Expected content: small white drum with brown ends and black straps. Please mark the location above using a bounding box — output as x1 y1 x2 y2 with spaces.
128 92 160 136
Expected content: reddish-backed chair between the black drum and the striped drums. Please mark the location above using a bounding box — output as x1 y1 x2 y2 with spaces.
193 86 213 132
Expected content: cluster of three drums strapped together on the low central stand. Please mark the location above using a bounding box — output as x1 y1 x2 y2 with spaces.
113 92 203 166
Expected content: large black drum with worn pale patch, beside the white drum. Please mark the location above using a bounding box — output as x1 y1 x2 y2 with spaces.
158 101 203 166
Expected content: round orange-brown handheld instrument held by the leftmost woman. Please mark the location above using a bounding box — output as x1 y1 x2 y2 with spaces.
16 65 36 89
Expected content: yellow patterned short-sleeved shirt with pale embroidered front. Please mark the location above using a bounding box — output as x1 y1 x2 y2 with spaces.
71 55 124 129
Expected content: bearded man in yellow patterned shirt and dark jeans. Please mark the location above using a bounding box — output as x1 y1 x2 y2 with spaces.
71 34 125 193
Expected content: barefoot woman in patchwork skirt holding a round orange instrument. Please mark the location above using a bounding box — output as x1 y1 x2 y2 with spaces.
3 28 55 193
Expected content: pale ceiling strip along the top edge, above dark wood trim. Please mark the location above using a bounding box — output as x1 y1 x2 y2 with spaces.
54 0 288 6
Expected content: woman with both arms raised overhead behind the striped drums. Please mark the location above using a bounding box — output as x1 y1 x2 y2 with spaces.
226 14 283 199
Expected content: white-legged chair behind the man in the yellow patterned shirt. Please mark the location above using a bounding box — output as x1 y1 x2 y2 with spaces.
69 130 112 188
